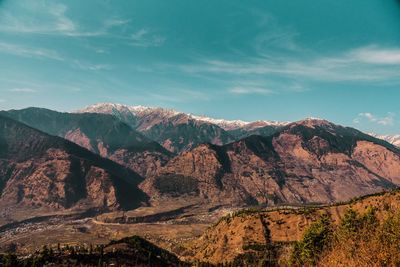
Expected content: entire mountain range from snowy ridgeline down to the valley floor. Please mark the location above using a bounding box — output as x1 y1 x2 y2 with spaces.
0 104 400 213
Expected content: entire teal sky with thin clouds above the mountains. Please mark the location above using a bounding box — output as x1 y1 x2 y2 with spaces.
0 0 400 134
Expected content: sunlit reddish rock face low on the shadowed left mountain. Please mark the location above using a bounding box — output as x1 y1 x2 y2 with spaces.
1 149 118 209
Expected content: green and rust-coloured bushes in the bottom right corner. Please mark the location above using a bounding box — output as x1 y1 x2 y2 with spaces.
290 207 400 266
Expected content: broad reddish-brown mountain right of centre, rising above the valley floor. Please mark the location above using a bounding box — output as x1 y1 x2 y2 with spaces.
141 119 400 205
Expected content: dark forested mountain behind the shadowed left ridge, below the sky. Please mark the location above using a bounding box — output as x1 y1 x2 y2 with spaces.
3 108 171 176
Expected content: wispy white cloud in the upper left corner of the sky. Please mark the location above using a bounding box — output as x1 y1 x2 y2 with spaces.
0 0 165 47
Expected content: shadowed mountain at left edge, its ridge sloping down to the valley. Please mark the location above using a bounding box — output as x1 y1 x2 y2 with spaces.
0 115 146 213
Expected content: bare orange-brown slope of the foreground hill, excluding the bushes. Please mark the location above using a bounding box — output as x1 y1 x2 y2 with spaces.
186 190 400 266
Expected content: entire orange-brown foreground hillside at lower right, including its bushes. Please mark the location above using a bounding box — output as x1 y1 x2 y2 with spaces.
185 190 400 266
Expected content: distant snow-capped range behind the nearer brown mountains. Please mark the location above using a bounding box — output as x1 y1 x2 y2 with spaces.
76 103 400 153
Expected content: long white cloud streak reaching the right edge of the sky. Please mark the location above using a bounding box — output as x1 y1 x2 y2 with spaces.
172 47 400 83
